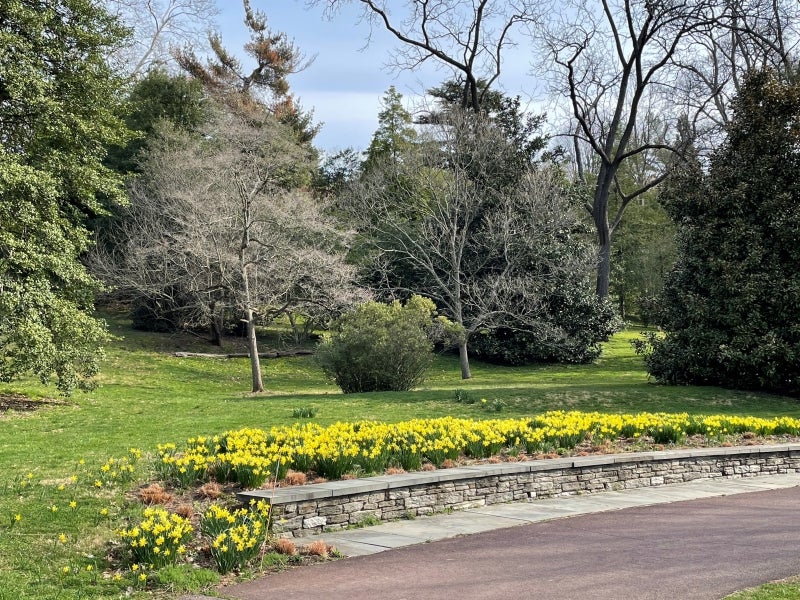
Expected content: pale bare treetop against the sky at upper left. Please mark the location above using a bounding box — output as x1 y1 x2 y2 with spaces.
103 0 219 79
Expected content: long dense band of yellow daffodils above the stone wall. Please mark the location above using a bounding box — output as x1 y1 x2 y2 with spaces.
159 411 800 488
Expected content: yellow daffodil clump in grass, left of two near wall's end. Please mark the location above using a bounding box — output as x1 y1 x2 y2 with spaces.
117 508 194 569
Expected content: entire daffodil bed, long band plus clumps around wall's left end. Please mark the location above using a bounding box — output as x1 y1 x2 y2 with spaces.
6 411 800 597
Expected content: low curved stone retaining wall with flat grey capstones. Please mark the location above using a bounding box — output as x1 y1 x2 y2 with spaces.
239 444 800 537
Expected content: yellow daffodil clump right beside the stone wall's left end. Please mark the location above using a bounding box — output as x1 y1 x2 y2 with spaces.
200 501 269 573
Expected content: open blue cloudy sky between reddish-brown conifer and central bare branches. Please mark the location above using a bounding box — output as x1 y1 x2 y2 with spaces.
217 0 536 151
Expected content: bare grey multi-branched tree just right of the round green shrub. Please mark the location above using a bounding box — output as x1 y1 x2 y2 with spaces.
345 111 595 379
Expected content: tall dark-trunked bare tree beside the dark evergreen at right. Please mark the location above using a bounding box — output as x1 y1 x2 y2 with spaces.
535 0 798 298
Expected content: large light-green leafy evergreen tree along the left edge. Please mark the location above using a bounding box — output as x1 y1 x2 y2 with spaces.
0 0 127 394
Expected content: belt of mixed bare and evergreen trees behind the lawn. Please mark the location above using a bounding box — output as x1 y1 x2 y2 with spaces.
0 0 800 393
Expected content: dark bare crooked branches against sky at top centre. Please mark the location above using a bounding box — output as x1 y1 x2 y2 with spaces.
314 0 535 111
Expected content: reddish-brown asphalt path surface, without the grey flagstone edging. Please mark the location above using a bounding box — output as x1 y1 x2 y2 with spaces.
220 487 800 600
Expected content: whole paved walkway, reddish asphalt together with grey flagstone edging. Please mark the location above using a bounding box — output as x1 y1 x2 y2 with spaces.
184 474 800 600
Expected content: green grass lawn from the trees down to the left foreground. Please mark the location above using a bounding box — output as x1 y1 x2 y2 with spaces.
0 318 800 600
